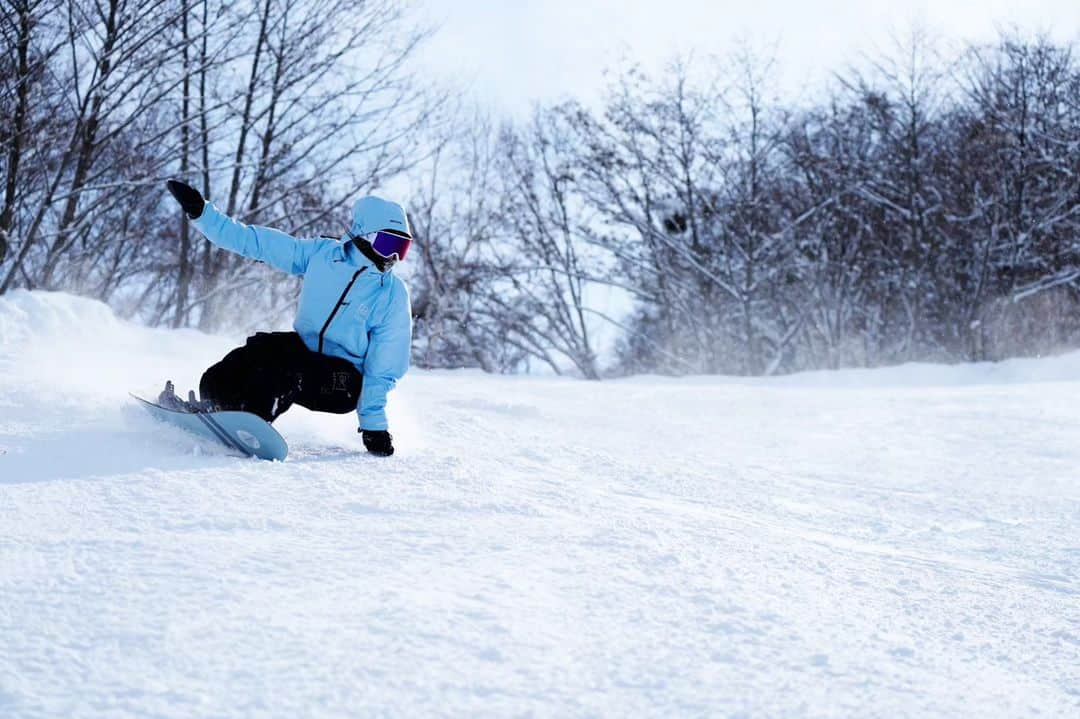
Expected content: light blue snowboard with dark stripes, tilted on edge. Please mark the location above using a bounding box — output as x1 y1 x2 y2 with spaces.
132 394 288 461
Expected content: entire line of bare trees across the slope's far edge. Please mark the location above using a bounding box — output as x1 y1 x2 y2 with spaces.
0 0 1080 377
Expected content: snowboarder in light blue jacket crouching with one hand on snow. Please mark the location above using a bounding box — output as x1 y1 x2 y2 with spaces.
162 180 413 457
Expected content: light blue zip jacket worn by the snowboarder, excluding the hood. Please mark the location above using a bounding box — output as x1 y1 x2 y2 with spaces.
192 202 413 430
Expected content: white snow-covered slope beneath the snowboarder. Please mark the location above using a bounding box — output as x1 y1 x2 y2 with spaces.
0 291 1080 717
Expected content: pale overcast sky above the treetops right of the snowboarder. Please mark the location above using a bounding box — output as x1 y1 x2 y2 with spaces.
415 0 1080 113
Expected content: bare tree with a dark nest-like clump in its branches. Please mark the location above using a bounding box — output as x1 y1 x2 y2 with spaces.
561 66 735 371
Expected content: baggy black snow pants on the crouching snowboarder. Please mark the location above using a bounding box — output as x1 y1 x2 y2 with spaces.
199 333 363 422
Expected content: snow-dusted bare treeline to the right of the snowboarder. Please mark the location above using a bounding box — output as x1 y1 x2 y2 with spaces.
408 33 1080 377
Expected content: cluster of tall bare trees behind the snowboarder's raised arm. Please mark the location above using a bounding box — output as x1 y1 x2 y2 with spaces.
0 0 438 338
